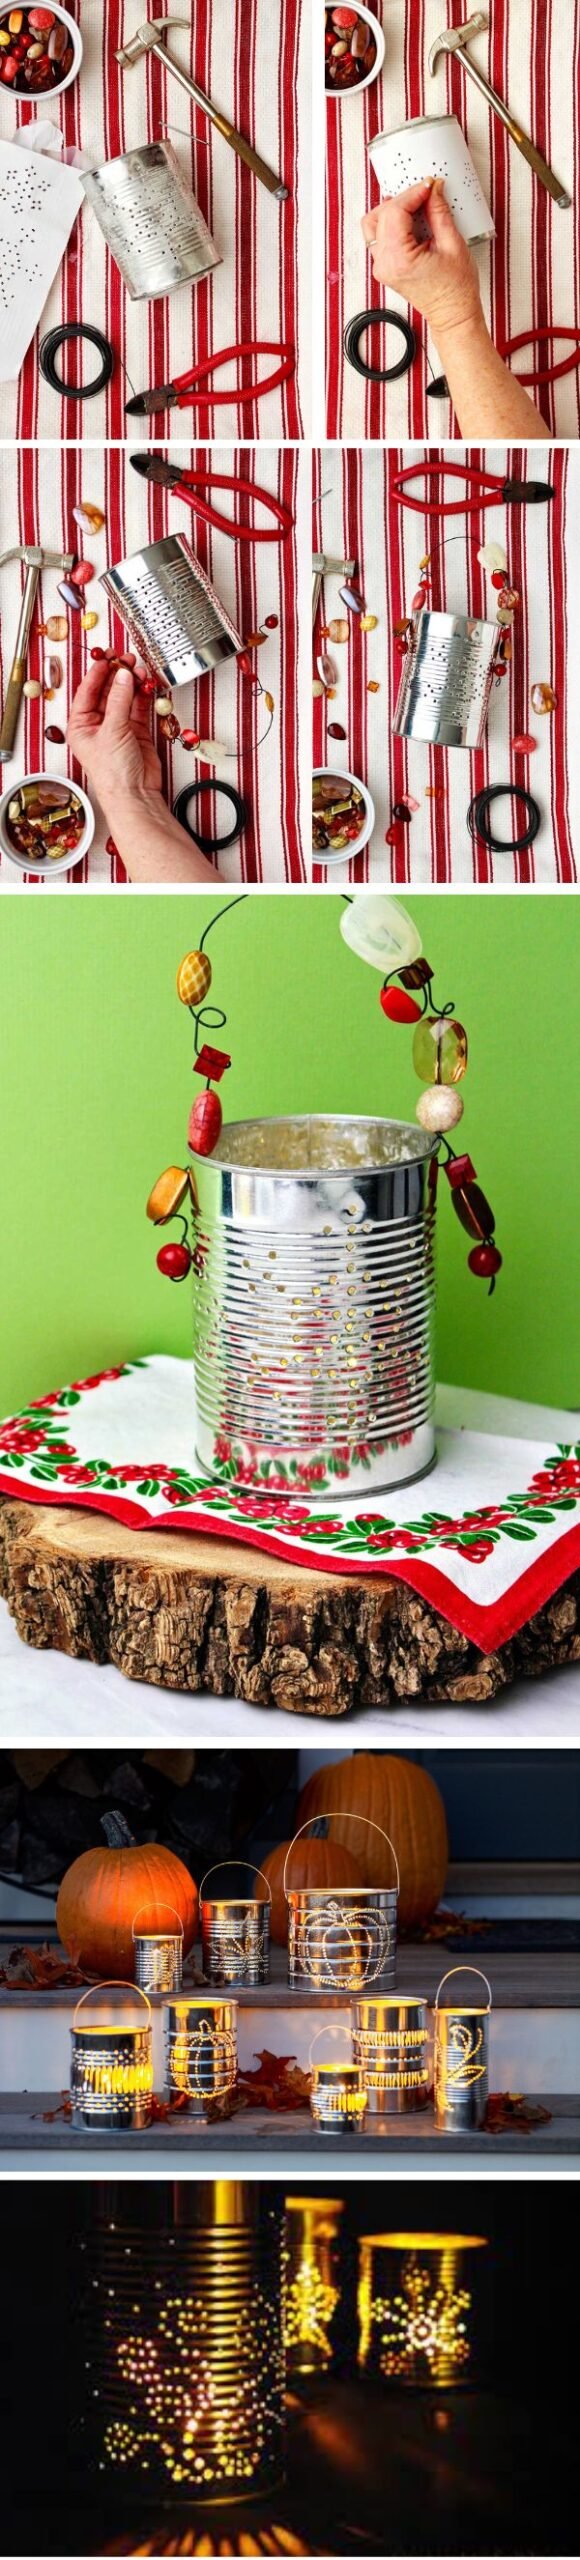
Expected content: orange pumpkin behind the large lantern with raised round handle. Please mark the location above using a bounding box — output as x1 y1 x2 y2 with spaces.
296 1751 450 1930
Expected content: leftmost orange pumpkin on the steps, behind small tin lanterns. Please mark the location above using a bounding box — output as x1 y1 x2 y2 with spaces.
56 1815 197 1981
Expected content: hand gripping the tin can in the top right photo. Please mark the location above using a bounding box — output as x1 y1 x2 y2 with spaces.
363 177 483 340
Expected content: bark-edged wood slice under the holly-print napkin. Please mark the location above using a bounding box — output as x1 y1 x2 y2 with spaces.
0 1498 580 1715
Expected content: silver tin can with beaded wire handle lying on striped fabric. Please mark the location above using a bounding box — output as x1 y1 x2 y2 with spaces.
393 607 503 748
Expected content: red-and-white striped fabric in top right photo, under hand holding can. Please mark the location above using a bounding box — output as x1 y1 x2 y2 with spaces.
327 0 580 440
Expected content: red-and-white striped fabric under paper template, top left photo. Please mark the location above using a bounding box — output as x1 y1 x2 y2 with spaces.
0 0 309 440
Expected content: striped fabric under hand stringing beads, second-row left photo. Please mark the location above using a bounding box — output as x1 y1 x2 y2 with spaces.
0 445 312 893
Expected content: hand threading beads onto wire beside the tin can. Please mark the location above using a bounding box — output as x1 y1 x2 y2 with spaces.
66 658 166 832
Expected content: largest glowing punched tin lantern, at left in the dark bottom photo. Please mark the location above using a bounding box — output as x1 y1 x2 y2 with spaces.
82 2179 286 2498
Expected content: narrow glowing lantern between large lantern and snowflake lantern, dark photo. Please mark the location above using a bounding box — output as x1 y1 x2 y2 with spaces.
284 2191 345 2381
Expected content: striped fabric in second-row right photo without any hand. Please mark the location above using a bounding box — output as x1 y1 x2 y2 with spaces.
314 445 580 888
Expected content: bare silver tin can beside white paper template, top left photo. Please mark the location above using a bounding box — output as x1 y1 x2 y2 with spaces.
82 143 222 302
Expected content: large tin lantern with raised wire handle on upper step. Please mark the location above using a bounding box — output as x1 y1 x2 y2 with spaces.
284 1812 399 1992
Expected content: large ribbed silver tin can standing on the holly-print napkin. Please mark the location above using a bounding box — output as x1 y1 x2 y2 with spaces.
194 1114 437 1498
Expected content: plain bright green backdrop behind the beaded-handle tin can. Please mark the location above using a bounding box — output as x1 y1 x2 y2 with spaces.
0 891 580 1413
